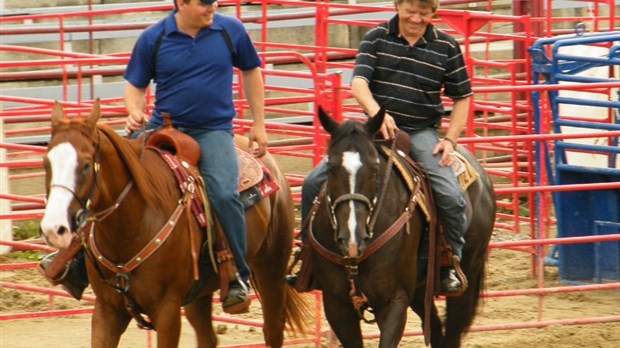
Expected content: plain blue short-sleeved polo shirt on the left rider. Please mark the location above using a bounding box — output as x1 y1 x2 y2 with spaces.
123 11 261 129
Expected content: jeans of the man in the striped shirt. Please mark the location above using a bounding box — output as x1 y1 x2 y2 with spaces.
301 128 467 259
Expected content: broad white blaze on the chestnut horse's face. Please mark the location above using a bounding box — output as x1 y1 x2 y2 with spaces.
41 143 78 248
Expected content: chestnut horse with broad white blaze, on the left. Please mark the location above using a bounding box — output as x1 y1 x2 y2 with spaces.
41 101 305 347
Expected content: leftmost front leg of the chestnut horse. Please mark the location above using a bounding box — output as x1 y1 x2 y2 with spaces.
91 299 131 348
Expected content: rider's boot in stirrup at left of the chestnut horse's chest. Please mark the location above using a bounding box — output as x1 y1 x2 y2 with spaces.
40 250 88 300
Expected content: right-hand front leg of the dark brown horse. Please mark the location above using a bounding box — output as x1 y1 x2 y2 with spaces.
375 292 409 348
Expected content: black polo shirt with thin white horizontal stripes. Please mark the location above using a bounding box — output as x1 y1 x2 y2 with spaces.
353 15 473 131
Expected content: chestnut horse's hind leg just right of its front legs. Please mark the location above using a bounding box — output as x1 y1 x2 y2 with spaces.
185 294 217 348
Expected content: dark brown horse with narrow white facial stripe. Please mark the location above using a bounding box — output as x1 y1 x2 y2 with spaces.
308 110 495 348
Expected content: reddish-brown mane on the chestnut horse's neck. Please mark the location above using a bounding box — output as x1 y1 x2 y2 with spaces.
97 124 170 208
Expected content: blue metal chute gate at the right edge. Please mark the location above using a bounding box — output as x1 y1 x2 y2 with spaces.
529 32 620 283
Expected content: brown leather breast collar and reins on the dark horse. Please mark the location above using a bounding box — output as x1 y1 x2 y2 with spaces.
305 142 422 324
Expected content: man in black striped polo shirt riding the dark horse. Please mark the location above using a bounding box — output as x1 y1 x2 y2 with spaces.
286 0 473 295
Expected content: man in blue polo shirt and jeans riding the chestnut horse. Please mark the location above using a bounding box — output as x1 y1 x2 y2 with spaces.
124 0 267 313
